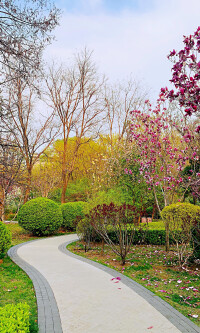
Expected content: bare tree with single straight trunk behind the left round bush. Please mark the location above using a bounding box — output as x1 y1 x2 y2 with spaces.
2 79 59 202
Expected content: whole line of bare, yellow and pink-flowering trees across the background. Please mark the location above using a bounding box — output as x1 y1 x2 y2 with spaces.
0 0 200 219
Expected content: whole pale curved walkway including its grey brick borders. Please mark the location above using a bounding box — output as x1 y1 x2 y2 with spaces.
8 235 200 333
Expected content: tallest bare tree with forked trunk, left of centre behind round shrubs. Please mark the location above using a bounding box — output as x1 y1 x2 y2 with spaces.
46 49 104 203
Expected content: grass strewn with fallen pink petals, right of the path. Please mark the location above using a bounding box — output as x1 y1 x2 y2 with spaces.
67 241 200 326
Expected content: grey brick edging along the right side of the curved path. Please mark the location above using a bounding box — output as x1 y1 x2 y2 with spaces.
58 240 200 333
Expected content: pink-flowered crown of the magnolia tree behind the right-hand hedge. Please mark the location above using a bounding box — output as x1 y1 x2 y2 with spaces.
130 99 197 191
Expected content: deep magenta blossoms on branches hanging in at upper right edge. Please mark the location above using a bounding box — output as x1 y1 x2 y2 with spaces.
160 27 200 133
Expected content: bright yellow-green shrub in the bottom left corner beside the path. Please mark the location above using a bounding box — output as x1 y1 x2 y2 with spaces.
0 303 30 333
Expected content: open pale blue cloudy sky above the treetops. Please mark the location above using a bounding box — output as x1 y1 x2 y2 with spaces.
44 0 200 99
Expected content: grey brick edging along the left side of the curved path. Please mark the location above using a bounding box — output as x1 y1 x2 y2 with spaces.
8 240 63 333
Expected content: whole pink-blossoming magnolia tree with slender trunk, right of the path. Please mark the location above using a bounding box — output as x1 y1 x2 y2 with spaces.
131 96 200 250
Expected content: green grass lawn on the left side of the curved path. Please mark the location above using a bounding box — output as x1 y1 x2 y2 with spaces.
0 223 69 333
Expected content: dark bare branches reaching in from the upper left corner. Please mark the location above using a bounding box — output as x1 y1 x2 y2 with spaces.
0 0 60 84
